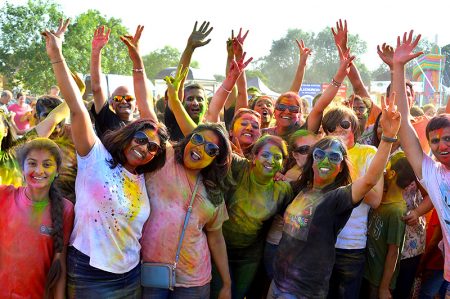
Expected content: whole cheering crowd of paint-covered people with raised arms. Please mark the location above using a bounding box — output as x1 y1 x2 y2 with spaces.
0 20 450 299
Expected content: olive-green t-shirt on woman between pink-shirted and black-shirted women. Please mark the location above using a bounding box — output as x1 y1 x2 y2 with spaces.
222 155 293 248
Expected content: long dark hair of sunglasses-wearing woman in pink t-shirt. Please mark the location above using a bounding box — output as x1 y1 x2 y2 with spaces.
174 123 233 206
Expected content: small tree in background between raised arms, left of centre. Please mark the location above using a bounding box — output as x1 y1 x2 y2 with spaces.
142 46 180 80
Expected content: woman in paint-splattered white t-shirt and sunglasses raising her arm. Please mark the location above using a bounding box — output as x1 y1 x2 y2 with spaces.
43 20 168 298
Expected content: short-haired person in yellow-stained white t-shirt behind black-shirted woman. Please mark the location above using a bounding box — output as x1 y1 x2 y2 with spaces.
322 105 383 298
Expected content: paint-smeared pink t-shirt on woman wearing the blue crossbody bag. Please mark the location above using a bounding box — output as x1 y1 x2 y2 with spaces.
141 147 228 287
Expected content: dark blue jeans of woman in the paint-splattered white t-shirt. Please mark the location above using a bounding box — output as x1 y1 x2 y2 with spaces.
67 246 141 299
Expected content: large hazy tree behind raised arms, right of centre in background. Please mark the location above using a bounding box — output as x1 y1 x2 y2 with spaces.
256 27 370 92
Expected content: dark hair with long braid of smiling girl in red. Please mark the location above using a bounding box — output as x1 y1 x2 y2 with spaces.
17 138 65 298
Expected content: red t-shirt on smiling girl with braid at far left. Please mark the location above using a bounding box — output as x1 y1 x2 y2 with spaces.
0 185 74 299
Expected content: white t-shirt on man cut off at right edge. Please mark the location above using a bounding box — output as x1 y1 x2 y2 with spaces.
420 154 450 281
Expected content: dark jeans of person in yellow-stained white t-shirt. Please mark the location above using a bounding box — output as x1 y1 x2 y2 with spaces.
328 248 366 299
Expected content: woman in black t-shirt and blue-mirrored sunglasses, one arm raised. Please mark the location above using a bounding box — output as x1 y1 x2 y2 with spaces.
268 95 401 298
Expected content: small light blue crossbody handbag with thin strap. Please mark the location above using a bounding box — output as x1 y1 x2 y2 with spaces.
141 176 200 291
